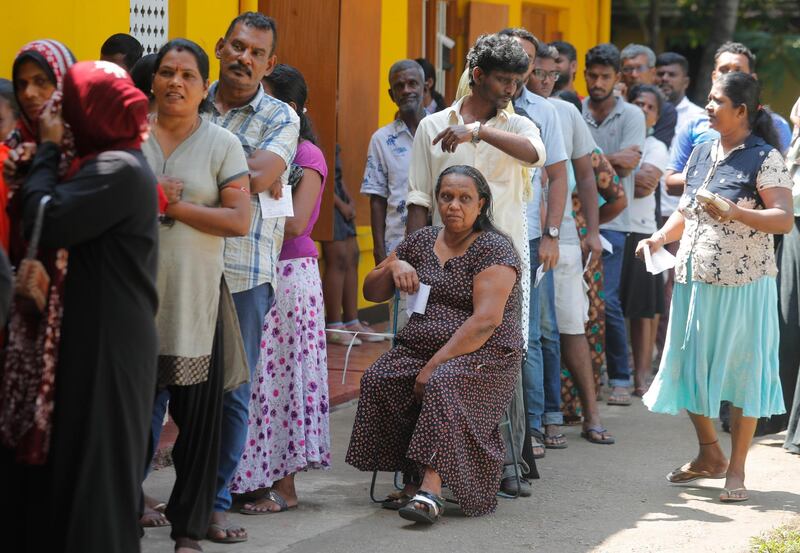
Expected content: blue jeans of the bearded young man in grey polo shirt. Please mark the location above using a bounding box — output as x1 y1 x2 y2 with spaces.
600 230 631 387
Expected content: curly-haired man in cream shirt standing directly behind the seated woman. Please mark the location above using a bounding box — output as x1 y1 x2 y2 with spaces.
406 35 558 495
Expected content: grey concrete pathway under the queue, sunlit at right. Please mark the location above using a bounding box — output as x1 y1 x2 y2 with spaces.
142 396 800 553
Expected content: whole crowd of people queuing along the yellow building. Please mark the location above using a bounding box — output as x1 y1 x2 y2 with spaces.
0 12 800 553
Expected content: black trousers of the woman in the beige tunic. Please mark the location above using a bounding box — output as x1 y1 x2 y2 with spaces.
164 322 224 540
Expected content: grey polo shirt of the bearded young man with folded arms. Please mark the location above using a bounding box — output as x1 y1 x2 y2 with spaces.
583 98 647 232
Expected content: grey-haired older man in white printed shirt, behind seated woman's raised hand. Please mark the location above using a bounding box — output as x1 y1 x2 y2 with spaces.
361 60 427 332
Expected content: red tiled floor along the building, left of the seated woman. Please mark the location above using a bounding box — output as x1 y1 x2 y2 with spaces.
158 323 390 452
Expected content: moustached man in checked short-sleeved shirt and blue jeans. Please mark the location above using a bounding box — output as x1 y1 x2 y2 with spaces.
206 12 300 543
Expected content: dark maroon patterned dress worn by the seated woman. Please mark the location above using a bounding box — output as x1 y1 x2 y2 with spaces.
346 227 523 516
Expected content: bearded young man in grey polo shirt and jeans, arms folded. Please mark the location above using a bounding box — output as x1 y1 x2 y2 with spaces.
583 44 646 405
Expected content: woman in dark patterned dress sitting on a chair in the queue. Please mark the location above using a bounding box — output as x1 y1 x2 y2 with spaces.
347 165 523 523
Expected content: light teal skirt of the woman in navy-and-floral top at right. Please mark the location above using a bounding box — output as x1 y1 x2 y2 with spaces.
643 266 786 418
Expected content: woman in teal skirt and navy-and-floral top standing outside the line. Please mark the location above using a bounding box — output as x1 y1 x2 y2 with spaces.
637 73 794 502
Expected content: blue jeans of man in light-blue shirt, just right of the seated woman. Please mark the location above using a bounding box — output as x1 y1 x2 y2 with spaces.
522 238 564 431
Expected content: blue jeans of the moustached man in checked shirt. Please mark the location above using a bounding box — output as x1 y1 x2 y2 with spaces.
214 283 275 512
